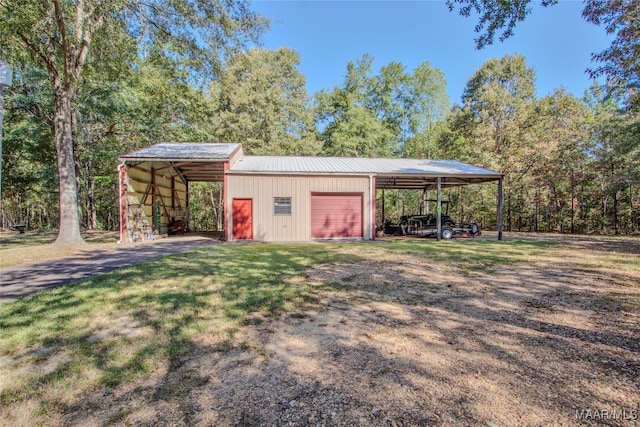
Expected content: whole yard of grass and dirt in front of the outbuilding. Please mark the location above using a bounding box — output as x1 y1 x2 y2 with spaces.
0 237 640 425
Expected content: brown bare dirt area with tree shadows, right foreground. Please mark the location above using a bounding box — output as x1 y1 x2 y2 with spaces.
74 234 640 426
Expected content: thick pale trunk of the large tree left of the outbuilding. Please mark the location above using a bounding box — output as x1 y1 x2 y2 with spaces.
54 79 84 246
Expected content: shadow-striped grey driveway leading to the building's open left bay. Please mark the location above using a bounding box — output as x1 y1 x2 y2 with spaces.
0 235 218 303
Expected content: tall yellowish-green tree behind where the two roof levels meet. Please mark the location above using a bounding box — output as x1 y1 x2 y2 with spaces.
211 48 320 155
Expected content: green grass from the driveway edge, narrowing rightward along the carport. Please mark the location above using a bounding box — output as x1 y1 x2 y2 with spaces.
0 239 640 424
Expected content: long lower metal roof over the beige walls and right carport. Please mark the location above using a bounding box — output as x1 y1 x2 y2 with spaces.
229 156 502 189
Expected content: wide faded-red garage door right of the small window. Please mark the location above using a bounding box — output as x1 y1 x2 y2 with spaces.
311 194 362 239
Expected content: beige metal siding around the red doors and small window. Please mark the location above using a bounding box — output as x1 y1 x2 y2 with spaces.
225 174 372 242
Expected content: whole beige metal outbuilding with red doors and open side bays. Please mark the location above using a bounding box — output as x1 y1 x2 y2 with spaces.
119 143 503 242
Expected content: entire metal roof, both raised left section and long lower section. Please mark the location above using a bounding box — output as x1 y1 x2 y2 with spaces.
119 142 502 189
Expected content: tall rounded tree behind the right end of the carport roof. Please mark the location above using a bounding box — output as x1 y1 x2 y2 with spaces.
445 55 544 229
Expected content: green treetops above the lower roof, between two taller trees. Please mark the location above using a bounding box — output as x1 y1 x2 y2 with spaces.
316 55 449 157
